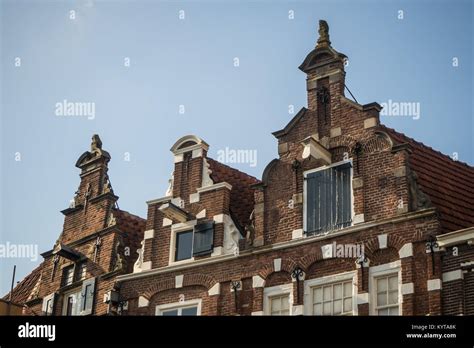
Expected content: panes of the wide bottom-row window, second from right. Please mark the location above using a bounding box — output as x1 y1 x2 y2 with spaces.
312 280 353 315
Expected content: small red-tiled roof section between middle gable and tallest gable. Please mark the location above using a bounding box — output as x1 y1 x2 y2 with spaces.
207 158 260 227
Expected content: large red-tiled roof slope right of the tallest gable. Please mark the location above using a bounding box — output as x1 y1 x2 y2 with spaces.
380 125 474 232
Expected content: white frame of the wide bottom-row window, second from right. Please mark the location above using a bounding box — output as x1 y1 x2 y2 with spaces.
303 271 358 316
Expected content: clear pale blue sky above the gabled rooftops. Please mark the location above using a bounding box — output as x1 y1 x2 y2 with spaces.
0 0 474 293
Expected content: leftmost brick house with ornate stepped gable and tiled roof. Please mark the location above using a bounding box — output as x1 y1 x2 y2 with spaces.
4 135 145 315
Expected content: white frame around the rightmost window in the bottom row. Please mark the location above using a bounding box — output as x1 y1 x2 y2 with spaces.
369 260 403 315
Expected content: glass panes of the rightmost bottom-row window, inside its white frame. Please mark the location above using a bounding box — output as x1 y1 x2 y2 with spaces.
375 273 399 315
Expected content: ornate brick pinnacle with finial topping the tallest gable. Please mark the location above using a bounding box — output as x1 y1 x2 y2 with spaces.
299 20 347 136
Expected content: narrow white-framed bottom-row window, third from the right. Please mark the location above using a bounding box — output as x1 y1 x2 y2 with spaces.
263 284 293 315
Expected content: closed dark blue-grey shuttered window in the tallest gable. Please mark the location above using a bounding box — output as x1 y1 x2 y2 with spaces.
304 162 352 234
